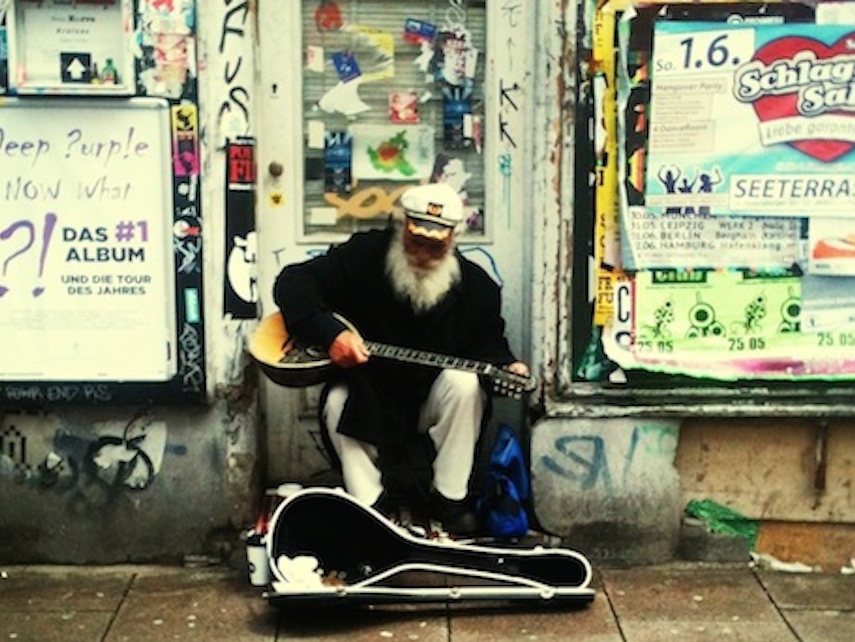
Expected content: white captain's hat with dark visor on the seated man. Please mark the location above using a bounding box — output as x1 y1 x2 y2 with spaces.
401 183 463 240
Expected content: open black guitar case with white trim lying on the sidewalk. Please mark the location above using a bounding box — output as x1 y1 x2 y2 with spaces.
267 488 594 607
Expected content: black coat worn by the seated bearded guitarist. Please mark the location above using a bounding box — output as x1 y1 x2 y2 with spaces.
274 229 516 446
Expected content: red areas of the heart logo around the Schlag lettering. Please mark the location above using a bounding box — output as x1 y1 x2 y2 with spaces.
754 34 855 163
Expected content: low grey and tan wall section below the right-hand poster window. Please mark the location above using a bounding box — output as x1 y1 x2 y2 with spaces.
531 417 855 571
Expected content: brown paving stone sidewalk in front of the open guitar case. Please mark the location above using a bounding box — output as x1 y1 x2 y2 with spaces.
0 563 855 642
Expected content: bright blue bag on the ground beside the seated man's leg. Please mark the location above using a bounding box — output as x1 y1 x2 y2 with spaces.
477 424 529 537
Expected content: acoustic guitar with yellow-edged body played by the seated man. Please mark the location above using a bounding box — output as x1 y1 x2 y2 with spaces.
249 312 537 398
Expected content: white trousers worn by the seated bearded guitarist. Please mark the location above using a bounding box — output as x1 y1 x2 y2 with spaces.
323 370 487 506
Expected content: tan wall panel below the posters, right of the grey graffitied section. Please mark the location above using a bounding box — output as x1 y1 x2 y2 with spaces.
676 417 855 572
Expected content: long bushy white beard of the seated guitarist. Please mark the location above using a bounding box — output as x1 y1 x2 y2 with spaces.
386 227 460 313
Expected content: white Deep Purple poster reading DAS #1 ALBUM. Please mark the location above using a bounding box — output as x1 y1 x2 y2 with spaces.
0 98 176 382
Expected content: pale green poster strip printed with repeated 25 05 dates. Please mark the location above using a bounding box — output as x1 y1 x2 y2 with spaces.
603 270 855 381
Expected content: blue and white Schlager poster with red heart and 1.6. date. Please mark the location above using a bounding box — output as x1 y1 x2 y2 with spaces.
645 21 855 217
